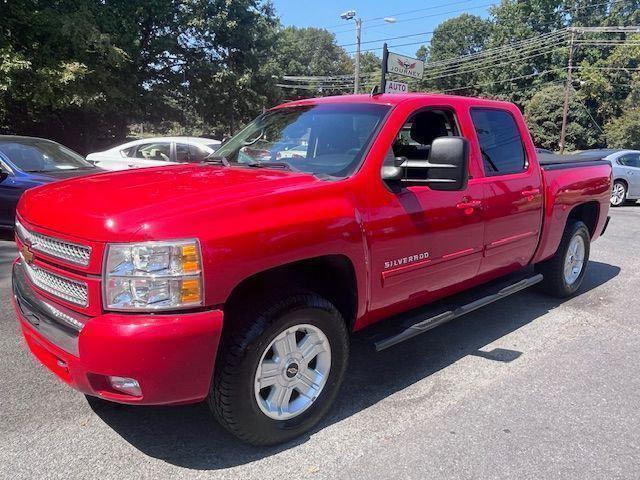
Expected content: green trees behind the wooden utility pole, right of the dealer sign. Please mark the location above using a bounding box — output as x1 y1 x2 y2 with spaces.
417 0 640 149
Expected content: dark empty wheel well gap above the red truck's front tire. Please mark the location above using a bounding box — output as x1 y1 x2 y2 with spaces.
224 255 358 327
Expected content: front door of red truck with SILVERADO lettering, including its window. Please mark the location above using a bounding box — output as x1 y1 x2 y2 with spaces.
367 107 484 317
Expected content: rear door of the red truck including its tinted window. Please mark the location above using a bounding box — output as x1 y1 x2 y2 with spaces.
471 108 543 273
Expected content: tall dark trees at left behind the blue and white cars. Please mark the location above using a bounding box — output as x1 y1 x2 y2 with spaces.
0 0 278 152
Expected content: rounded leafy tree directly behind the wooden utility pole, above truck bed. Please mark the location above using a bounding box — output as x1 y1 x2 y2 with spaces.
525 85 602 150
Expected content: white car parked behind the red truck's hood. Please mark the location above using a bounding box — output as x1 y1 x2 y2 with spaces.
87 137 221 170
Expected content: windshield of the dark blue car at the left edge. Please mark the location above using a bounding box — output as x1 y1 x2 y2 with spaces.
0 138 93 172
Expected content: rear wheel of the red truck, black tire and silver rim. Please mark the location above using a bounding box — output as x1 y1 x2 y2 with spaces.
536 221 591 298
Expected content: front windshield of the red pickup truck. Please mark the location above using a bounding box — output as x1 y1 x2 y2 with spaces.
215 103 389 178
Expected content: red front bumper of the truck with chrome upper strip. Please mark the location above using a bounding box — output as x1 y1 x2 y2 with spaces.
13 261 223 405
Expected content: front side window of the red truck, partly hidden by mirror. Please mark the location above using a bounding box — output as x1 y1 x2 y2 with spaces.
384 109 458 165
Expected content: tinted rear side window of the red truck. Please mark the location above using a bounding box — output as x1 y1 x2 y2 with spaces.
471 108 528 176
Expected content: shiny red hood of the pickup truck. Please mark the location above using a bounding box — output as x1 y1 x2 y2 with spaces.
18 165 320 241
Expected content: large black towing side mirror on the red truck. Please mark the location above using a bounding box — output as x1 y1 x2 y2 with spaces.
382 137 469 191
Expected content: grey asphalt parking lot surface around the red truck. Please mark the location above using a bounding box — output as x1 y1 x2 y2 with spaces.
0 205 640 480
